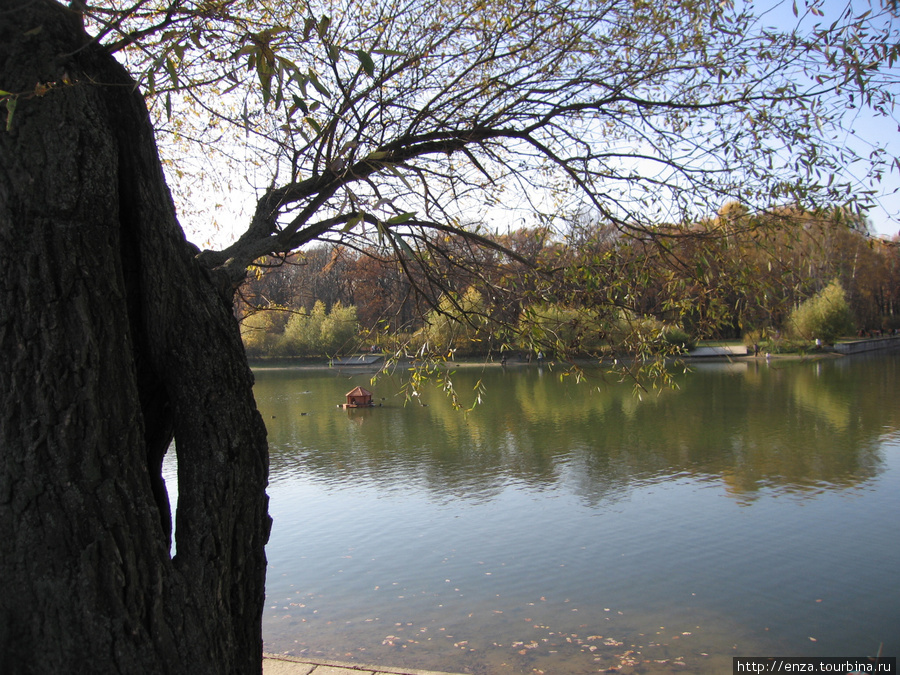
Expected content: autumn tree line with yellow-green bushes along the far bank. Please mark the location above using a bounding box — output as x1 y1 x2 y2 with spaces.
237 202 900 356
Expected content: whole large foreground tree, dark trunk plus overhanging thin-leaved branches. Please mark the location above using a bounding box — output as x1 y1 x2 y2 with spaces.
0 0 898 673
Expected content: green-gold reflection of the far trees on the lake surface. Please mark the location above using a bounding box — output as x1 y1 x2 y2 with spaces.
257 359 900 503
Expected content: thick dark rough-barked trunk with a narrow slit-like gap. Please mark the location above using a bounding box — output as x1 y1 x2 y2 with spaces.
0 0 269 674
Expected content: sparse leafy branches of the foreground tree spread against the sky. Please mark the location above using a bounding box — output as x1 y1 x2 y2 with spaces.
68 0 900 264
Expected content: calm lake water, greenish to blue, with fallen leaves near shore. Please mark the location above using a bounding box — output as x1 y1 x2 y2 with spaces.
193 353 900 674
